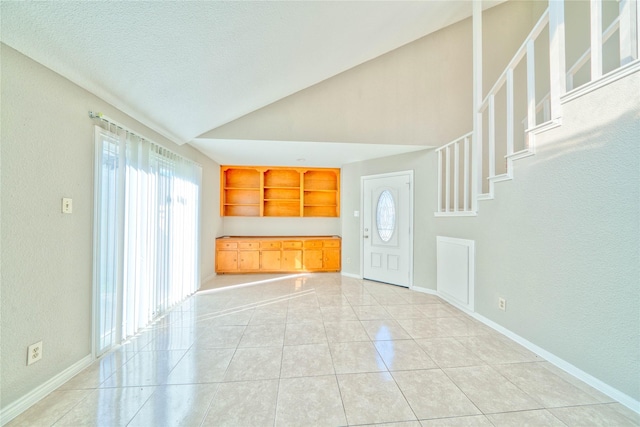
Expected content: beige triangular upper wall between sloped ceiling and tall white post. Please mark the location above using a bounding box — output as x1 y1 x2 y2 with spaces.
201 7 472 146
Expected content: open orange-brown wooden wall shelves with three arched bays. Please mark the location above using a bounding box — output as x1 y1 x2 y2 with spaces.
220 166 340 217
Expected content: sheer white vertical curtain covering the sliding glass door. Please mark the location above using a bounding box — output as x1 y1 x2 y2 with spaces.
95 126 202 354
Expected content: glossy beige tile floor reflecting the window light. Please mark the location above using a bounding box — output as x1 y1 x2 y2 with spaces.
9 273 640 427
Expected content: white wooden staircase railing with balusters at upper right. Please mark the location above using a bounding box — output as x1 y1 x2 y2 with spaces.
435 0 640 216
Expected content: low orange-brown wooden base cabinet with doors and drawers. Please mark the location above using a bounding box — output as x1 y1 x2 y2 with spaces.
216 236 341 274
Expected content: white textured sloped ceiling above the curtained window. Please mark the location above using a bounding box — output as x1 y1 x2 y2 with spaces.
0 0 484 166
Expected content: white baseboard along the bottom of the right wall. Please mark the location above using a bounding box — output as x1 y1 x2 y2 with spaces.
472 310 640 414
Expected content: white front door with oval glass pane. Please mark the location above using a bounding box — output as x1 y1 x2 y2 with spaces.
362 171 413 287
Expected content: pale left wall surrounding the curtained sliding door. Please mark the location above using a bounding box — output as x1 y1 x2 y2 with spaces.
0 45 221 408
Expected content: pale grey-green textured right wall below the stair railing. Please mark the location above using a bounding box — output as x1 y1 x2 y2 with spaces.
430 73 640 400
